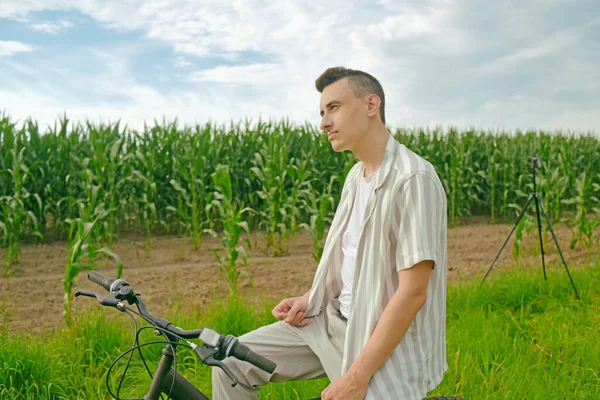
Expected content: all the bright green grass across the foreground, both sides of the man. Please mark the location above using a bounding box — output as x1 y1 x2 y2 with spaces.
0 259 600 399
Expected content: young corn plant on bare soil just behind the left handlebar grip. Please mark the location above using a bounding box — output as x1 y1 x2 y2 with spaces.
62 218 123 327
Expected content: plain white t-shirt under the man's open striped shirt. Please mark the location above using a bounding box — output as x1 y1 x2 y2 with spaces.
339 164 377 318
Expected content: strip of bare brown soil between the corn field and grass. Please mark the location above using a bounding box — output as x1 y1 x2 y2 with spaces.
0 218 600 333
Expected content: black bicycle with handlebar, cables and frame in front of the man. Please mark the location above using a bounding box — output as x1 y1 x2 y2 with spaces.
75 271 464 400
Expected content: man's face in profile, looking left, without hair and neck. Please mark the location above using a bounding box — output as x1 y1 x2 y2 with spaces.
320 78 369 152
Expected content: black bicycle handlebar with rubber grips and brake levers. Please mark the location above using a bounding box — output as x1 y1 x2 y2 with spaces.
75 270 277 373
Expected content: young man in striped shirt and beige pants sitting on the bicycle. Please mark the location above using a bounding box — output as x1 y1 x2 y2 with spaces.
213 67 448 400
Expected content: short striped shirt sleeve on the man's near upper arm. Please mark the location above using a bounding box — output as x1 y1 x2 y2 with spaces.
392 173 446 271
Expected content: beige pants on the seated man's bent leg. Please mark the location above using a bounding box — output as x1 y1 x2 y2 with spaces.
212 299 346 400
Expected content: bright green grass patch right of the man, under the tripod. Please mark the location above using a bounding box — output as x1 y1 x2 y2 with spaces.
436 262 600 399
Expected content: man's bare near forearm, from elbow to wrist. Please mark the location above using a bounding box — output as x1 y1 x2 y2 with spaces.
348 291 427 385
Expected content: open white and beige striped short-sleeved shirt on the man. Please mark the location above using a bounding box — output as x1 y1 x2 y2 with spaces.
307 135 448 400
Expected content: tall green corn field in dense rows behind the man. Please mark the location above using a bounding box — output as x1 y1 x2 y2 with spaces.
0 115 600 269
